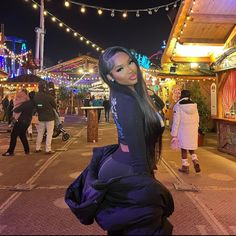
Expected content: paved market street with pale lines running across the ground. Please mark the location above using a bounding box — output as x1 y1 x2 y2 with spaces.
0 117 236 235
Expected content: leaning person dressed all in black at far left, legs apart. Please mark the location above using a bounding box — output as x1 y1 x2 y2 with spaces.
2 91 35 156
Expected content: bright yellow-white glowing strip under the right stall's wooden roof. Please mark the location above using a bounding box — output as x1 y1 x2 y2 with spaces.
175 43 223 57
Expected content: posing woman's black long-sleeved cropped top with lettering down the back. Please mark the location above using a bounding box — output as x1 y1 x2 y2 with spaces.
111 91 150 173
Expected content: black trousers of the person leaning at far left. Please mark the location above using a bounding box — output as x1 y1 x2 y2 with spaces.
7 121 29 153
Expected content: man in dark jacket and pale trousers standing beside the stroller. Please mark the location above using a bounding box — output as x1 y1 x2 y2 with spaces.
34 81 56 154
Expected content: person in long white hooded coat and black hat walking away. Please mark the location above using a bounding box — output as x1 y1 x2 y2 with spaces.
171 90 201 174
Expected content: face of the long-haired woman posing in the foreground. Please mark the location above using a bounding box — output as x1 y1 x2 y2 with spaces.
108 52 138 90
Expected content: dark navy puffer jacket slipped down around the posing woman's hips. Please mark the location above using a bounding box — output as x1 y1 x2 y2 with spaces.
65 145 174 235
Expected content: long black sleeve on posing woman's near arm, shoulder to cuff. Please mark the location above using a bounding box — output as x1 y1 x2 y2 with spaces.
116 95 148 172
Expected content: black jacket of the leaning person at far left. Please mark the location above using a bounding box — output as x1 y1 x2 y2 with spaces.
14 100 35 124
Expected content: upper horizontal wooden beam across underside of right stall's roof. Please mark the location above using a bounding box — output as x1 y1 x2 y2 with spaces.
190 13 236 24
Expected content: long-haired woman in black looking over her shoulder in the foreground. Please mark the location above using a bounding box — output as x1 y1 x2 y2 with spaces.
65 46 174 235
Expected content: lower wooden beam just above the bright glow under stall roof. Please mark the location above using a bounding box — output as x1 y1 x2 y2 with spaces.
180 38 225 46
